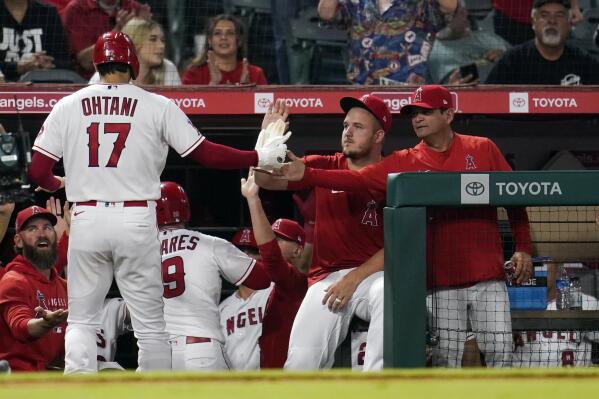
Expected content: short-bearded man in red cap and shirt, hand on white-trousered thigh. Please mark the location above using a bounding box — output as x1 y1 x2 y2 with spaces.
255 94 391 371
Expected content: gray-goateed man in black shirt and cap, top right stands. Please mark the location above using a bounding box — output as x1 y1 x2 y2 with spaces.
486 0 599 86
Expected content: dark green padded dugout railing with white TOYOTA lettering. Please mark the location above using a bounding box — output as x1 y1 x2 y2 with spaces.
384 171 599 368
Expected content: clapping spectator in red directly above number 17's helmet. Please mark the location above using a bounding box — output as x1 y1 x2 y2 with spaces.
62 0 152 79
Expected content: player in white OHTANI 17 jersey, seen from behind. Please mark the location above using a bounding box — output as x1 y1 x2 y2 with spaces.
29 32 289 374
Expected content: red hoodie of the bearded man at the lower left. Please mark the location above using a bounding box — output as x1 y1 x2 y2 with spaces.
0 255 67 371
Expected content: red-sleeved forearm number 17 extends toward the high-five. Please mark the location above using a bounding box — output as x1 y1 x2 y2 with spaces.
189 139 258 169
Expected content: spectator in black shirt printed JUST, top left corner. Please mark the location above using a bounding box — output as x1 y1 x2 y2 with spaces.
0 0 70 81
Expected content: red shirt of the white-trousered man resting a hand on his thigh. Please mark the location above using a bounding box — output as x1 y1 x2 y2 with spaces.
288 153 384 285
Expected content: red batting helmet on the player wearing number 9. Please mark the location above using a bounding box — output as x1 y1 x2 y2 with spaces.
156 181 191 226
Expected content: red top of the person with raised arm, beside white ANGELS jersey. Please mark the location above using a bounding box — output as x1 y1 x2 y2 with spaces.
258 240 308 369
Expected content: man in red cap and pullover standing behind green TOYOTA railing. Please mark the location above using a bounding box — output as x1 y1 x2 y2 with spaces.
280 85 532 366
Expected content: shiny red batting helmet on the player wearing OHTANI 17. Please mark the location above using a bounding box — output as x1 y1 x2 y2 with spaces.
93 32 139 79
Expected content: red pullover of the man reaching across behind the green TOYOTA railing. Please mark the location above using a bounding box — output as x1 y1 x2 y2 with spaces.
303 134 531 288
